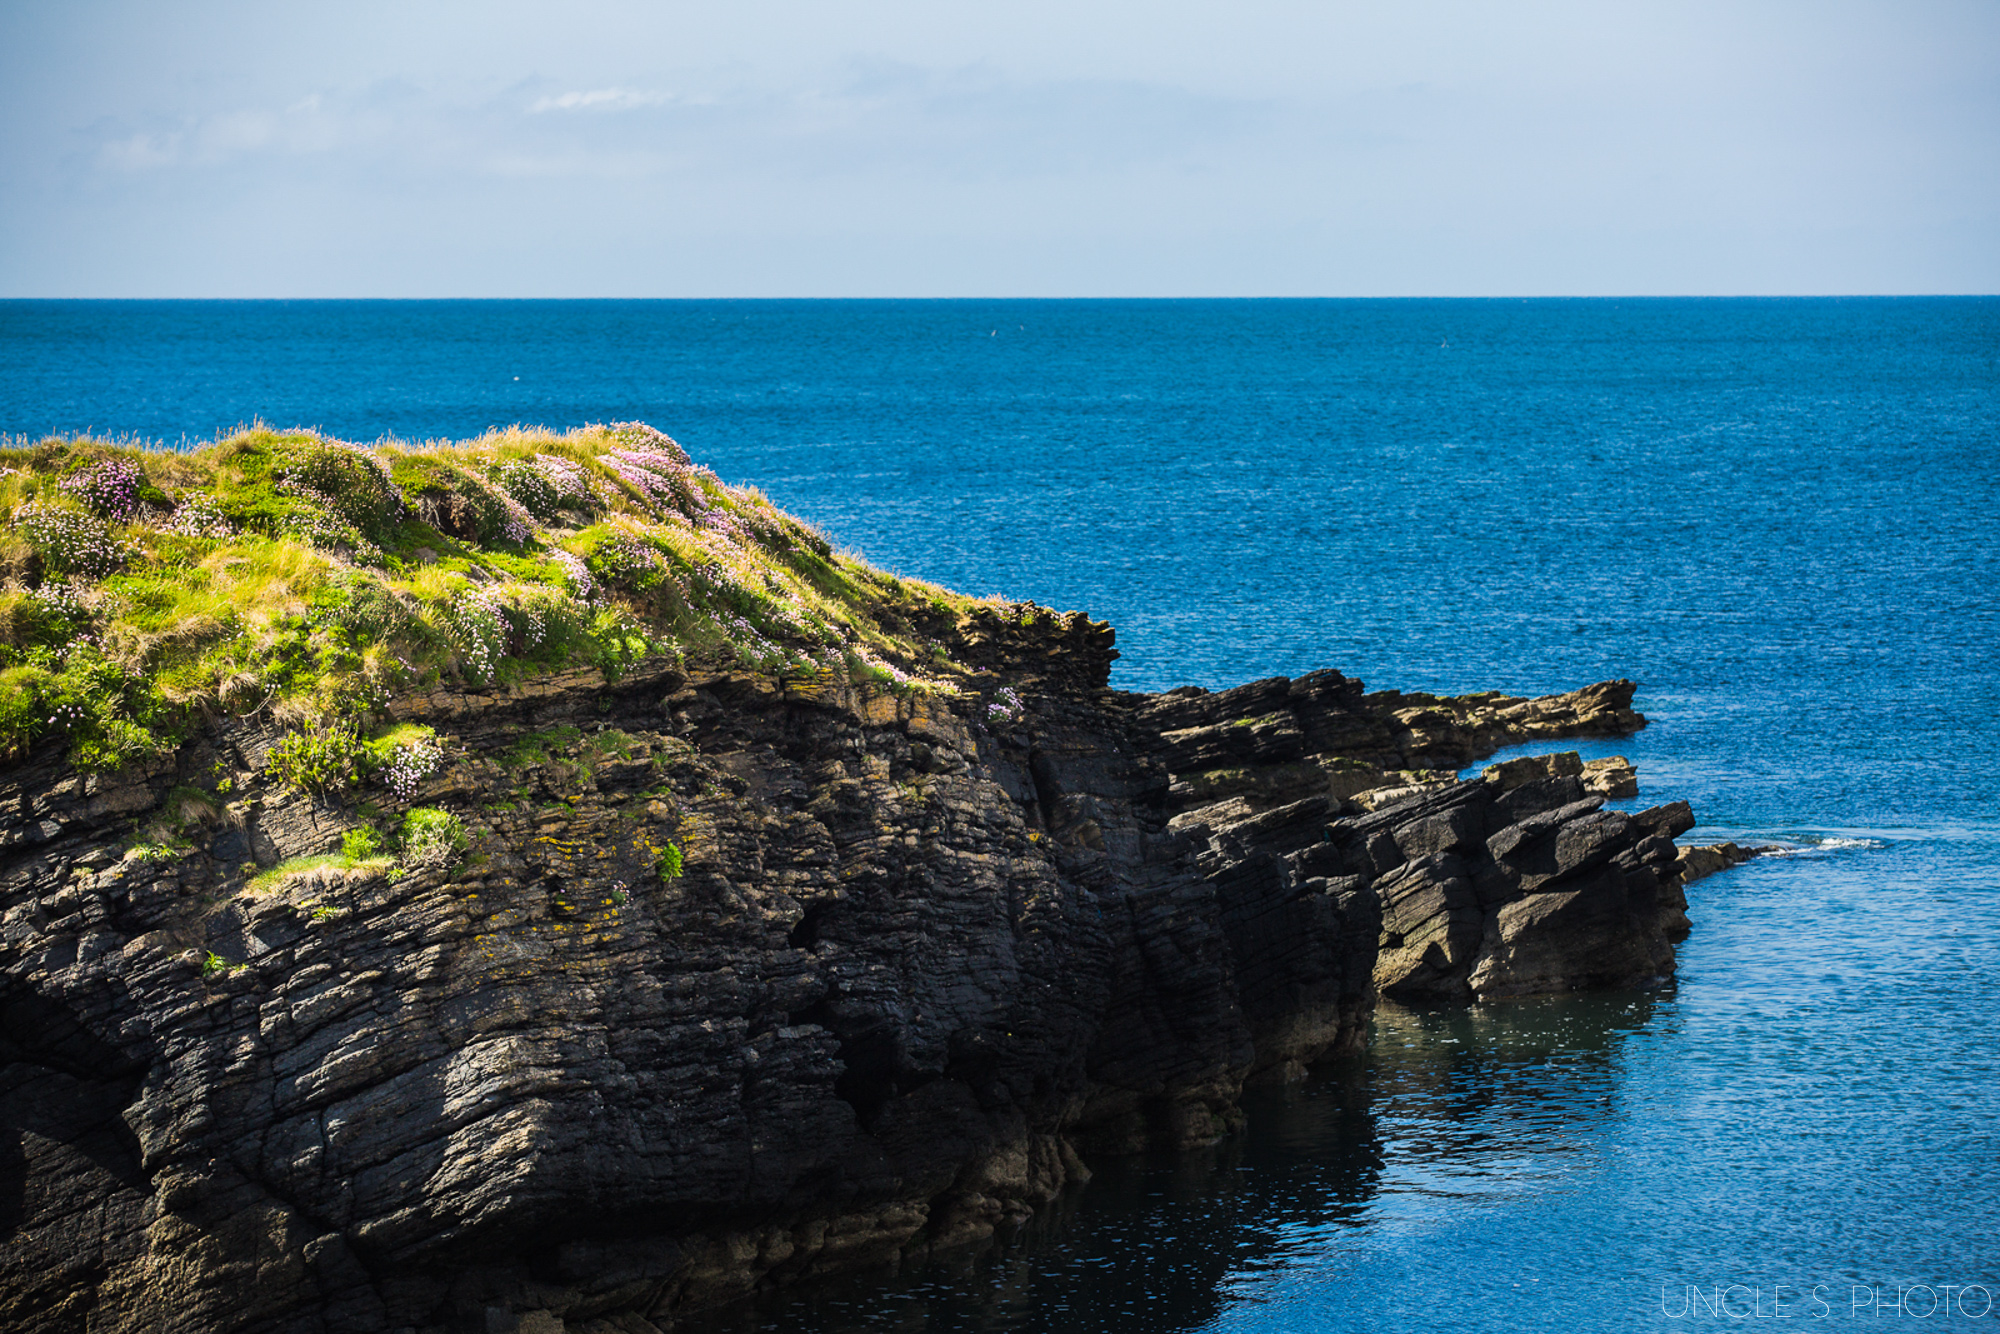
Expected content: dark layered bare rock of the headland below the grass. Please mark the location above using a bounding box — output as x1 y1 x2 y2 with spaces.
0 616 1692 1332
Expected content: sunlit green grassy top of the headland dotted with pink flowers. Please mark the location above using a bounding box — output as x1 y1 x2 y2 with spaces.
0 422 982 782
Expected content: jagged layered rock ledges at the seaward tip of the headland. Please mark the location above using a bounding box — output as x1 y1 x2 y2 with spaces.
1146 672 1694 1012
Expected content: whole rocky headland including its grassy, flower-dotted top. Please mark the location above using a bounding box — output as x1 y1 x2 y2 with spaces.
0 428 1736 1334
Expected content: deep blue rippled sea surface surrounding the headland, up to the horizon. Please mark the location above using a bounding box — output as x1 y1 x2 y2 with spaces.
0 298 2000 1334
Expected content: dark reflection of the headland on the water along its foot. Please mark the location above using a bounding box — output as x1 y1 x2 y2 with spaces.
682 992 1672 1334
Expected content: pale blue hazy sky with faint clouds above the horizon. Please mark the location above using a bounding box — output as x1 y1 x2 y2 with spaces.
0 0 2000 298
